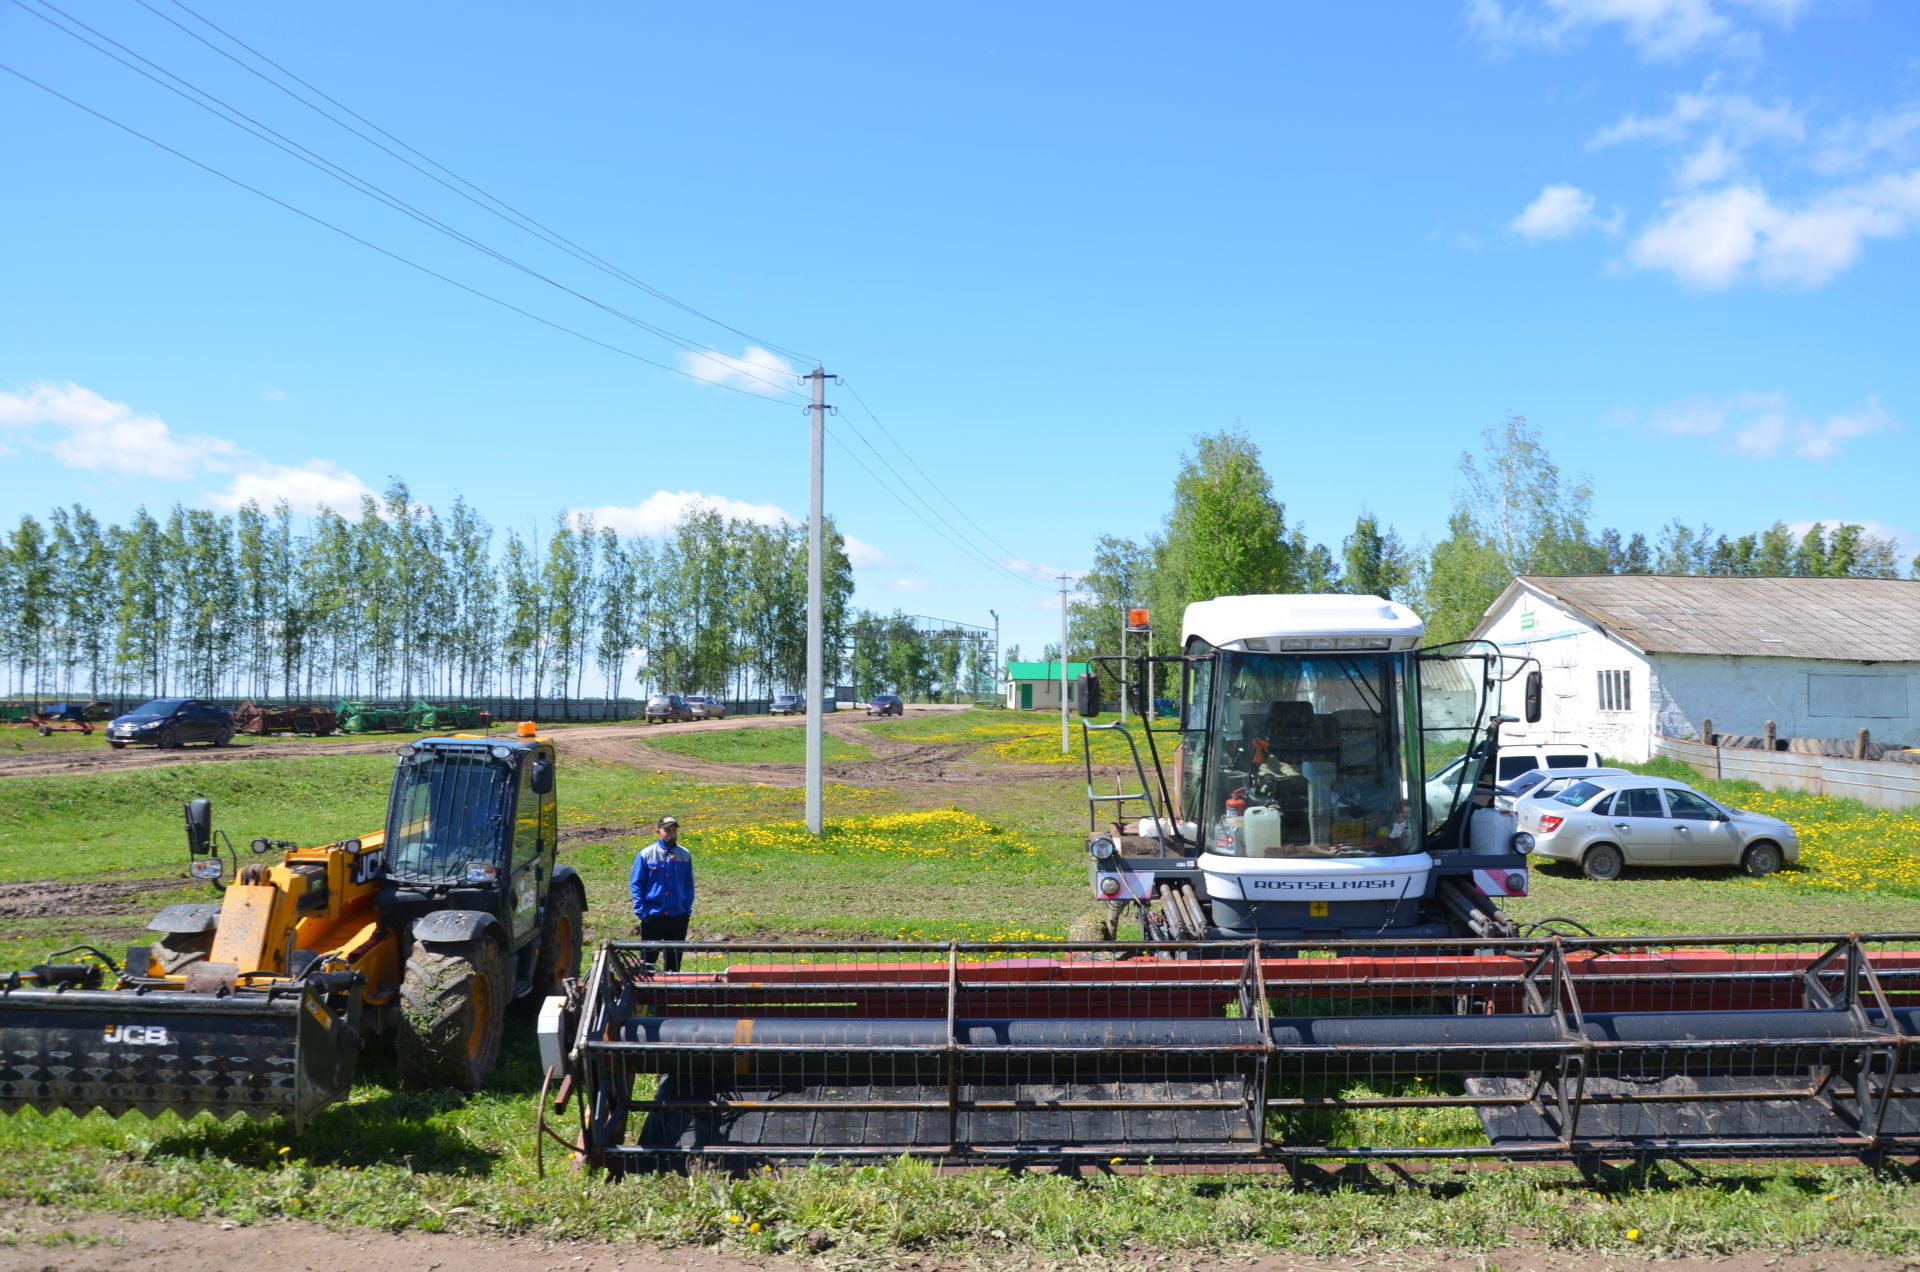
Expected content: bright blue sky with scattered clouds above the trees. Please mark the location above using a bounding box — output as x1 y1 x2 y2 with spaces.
0 0 1920 651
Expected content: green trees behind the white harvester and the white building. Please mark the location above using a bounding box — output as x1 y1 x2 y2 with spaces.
1046 415 1920 657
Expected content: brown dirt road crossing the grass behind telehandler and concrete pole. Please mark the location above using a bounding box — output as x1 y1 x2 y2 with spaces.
0 705 973 786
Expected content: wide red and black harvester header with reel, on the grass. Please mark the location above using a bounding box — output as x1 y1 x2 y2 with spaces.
568 936 1920 1170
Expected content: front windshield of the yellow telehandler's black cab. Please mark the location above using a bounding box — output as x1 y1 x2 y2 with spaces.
386 747 513 882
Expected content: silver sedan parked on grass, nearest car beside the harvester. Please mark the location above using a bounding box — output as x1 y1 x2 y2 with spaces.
1515 772 1799 880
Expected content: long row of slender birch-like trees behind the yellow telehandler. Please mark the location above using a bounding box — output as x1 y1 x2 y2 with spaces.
0 480 898 705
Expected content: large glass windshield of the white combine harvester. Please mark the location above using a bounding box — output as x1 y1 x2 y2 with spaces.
1183 649 1415 857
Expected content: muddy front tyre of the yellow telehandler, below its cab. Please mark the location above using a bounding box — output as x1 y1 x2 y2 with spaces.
394 940 513 1091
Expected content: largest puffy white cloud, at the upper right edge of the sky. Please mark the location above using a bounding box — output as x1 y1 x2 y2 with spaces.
1626 169 1920 290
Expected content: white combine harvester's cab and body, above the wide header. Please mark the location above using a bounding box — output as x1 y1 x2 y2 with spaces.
1081 596 1538 942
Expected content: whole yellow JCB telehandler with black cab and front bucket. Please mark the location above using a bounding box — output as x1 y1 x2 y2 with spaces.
0 734 586 1124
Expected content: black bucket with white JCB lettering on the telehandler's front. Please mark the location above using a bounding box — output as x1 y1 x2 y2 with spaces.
0 972 359 1126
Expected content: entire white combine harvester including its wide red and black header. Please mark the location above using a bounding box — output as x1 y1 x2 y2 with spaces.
543 596 1920 1168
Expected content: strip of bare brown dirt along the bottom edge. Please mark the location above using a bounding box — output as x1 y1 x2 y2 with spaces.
0 1209 1916 1272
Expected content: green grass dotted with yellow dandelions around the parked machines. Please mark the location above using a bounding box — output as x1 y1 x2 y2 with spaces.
0 711 1920 1264
